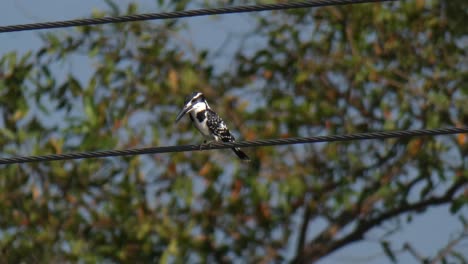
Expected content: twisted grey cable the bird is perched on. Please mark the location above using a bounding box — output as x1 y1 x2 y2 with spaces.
0 127 468 164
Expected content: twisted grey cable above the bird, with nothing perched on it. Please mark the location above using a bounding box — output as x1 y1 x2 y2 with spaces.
0 0 397 33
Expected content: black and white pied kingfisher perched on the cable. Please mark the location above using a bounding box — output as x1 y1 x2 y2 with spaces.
176 92 250 161
